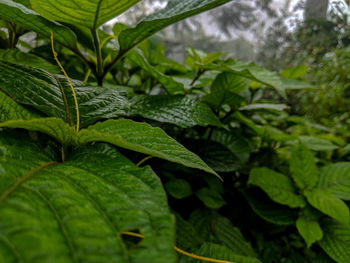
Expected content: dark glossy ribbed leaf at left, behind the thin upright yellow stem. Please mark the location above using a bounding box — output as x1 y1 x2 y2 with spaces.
0 60 129 127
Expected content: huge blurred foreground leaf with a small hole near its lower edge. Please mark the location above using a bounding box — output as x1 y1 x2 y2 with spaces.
0 133 176 263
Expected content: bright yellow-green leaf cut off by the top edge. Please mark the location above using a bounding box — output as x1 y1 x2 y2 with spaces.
31 0 140 29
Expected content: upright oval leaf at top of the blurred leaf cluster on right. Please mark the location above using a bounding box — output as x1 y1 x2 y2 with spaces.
290 144 318 189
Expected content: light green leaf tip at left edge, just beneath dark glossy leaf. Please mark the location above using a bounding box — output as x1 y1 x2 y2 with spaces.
0 91 40 122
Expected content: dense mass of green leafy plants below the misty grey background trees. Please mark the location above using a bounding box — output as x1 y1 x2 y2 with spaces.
0 0 350 263
